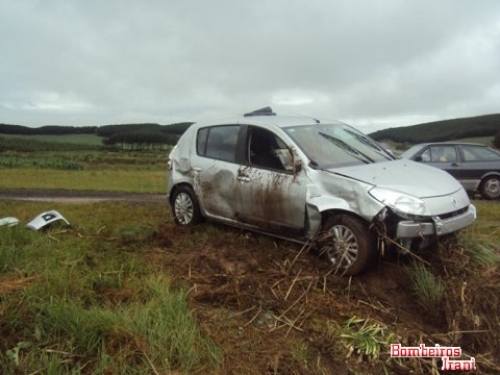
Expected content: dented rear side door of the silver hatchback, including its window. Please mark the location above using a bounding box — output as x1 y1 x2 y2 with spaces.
192 124 242 221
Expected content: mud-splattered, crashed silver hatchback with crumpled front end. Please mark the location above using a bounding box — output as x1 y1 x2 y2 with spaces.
168 107 476 275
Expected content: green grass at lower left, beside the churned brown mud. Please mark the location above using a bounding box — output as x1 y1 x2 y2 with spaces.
0 202 221 374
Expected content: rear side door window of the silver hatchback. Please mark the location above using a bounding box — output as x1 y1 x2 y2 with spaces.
196 125 240 163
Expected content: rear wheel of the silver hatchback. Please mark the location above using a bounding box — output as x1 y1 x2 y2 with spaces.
172 186 203 227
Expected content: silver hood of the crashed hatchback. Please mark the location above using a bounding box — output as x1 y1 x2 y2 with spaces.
328 159 462 198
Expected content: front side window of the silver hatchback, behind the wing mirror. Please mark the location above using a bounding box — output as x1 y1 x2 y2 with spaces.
247 128 293 172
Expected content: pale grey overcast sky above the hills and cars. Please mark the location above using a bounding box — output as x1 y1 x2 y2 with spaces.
0 0 500 132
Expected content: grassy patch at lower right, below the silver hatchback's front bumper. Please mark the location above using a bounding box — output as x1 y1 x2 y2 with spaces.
406 202 500 373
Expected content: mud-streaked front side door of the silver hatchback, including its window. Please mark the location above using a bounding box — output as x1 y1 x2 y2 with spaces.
232 126 306 236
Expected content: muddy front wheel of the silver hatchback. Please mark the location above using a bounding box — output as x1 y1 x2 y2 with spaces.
317 214 377 276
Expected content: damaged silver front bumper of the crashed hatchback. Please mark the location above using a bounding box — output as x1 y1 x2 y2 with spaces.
396 204 476 238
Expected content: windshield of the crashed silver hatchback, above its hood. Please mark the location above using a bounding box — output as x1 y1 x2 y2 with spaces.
284 124 394 169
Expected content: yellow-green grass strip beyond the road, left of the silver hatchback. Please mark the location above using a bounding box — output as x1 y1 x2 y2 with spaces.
0 151 168 194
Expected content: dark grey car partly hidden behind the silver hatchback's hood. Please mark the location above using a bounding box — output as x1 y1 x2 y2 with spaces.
401 142 500 199
